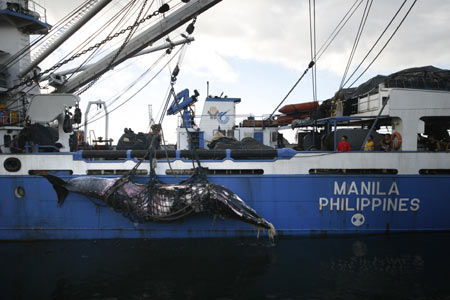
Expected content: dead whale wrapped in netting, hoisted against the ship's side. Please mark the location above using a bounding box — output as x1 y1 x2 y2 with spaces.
44 175 275 236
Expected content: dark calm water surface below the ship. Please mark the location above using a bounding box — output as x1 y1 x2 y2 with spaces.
0 234 450 300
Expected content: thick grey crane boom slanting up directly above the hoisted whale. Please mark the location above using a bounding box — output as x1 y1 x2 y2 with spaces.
56 0 222 93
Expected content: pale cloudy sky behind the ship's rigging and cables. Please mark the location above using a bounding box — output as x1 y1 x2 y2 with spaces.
37 0 450 142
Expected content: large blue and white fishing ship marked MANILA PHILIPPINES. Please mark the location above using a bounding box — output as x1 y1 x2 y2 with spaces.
0 0 450 240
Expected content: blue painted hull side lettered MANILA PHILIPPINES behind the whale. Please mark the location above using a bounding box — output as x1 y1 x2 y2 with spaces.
0 175 450 240
